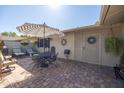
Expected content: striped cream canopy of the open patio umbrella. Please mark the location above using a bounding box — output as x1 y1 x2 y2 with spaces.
17 23 64 38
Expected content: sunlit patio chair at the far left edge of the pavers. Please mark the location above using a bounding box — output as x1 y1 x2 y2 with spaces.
0 51 17 73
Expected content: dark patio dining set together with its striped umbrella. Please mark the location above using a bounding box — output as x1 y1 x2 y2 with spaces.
16 22 64 67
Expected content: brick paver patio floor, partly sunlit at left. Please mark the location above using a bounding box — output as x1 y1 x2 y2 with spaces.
0 58 124 88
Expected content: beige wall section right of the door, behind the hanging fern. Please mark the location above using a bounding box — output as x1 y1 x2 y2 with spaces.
101 27 121 66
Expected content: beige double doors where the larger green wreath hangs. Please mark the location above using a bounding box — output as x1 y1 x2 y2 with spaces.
74 29 101 64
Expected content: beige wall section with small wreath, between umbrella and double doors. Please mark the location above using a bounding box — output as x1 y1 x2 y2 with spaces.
51 32 74 60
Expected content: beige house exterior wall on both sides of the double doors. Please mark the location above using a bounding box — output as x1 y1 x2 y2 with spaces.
51 22 124 66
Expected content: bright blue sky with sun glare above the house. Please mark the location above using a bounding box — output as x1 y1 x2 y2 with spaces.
0 5 101 34
